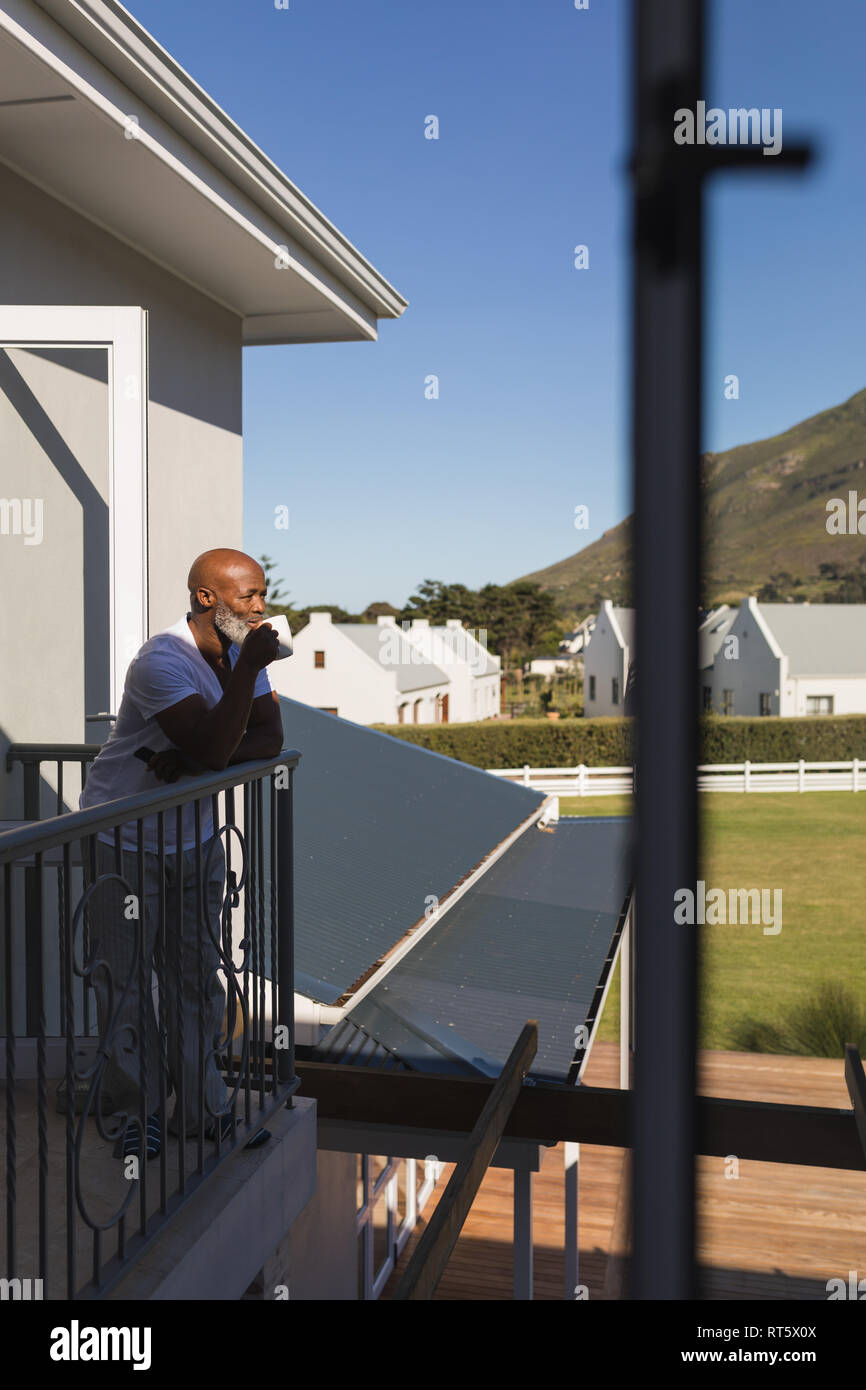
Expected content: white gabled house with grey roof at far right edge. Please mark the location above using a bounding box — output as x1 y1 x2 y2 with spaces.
705 596 866 716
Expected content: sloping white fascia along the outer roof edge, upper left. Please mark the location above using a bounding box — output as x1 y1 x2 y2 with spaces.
27 0 407 318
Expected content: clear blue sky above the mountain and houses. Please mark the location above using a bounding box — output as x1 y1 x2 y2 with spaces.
131 0 866 609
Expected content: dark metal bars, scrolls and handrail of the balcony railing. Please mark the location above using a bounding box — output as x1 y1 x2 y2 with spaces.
0 744 300 1298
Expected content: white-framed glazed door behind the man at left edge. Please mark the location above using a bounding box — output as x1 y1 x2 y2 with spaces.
0 304 147 817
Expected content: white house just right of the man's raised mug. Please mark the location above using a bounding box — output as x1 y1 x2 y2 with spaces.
270 613 450 724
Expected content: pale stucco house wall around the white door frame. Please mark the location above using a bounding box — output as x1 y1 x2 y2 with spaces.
0 164 243 815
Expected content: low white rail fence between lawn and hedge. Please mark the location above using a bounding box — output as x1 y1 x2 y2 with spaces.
489 758 866 796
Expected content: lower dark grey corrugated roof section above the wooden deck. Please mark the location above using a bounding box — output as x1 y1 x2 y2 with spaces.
313 817 630 1081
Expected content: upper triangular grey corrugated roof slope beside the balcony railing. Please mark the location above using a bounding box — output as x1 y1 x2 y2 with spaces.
271 696 545 1004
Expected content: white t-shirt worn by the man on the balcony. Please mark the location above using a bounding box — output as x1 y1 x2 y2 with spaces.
78 614 271 853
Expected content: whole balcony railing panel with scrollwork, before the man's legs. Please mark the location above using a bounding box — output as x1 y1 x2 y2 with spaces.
0 744 300 1298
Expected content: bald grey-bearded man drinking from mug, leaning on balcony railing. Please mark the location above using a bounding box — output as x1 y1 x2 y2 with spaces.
79 549 282 1158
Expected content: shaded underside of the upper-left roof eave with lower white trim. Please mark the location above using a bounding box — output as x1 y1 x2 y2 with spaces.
0 0 403 343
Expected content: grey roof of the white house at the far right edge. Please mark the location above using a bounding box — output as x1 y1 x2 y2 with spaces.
758 603 866 676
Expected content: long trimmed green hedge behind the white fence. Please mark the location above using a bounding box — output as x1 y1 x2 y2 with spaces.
375 714 866 767
